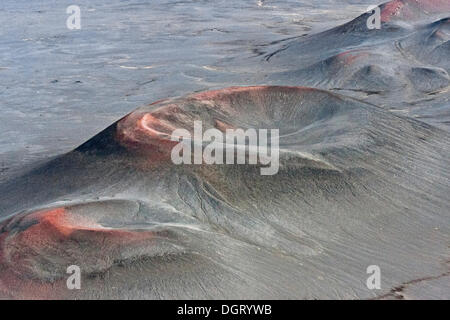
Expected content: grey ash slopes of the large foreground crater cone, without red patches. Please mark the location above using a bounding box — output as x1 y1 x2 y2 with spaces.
0 87 450 299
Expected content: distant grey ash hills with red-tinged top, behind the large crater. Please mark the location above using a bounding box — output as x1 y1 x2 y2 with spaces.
263 0 450 130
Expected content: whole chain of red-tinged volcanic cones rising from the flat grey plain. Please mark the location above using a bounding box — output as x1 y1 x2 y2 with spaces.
0 0 450 299
